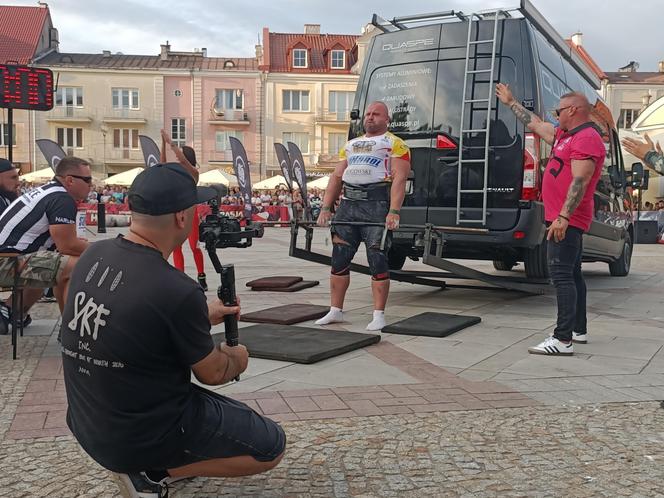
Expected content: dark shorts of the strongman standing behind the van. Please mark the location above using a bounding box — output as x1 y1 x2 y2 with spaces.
331 199 392 252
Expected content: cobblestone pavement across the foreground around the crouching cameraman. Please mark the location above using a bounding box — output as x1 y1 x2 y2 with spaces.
0 402 664 497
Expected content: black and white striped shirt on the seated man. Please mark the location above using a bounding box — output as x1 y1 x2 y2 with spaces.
0 180 76 253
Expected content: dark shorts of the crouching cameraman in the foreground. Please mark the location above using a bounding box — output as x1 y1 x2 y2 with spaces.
168 386 286 469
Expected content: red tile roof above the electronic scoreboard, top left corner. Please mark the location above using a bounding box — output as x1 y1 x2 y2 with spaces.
0 5 49 64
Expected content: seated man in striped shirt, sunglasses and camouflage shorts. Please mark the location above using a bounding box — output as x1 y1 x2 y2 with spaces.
0 157 92 334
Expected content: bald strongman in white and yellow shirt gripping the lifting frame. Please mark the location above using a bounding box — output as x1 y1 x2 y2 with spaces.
316 102 410 330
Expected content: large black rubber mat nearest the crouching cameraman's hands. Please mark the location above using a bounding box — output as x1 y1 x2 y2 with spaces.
212 323 380 364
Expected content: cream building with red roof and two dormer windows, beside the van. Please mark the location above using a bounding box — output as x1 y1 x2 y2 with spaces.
257 24 358 176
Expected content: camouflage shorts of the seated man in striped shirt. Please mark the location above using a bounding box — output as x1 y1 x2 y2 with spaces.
0 251 68 288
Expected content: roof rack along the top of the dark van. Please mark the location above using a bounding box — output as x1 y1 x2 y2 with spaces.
371 0 601 90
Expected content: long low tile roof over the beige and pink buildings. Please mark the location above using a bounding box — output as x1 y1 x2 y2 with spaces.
38 52 258 71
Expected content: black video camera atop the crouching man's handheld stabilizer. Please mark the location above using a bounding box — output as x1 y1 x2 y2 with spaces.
198 186 264 251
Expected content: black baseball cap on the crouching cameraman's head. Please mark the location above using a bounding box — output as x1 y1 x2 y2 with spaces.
128 163 217 216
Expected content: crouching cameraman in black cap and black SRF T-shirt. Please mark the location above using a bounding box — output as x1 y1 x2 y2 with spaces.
61 163 286 497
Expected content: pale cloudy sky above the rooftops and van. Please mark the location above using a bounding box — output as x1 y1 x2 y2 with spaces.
10 0 664 71
